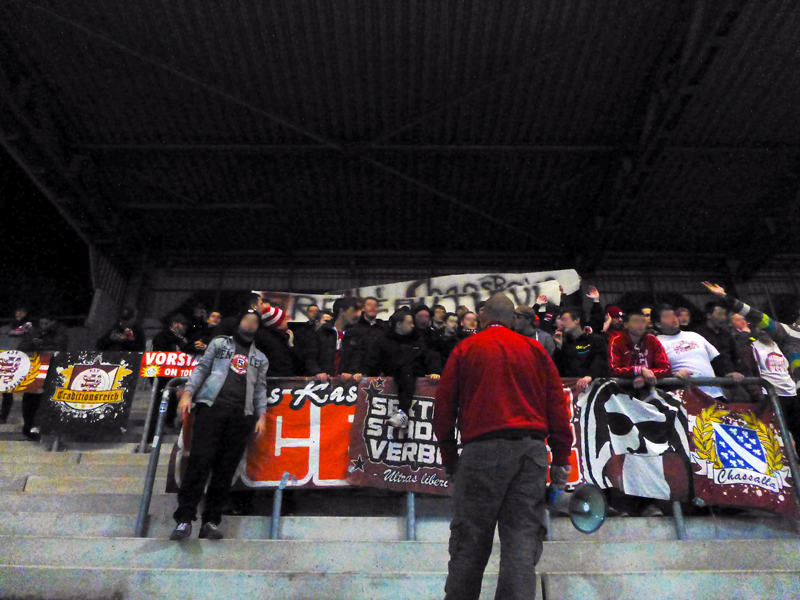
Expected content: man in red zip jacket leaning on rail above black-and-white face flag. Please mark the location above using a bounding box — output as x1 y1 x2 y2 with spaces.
608 310 672 389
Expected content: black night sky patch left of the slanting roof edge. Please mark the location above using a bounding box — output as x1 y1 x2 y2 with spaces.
0 148 92 319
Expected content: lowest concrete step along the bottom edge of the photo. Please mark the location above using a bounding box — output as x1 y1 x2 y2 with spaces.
6 567 800 600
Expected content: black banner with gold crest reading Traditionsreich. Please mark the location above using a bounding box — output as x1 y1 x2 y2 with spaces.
37 352 142 441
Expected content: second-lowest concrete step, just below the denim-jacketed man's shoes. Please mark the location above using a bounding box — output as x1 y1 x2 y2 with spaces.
0 532 800 574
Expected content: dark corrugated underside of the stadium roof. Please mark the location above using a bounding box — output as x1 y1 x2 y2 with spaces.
0 0 800 271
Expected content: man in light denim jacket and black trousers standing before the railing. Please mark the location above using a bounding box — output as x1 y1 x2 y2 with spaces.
170 309 269 540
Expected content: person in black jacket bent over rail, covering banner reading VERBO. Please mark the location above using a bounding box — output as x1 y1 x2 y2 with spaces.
364 308 442 429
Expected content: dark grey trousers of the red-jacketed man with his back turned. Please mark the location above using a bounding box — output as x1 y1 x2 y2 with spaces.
445 438 547 600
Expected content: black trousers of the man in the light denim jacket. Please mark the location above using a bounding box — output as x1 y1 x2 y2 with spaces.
173 404 256 525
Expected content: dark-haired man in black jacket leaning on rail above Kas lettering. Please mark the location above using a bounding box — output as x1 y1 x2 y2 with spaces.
306 296 362 381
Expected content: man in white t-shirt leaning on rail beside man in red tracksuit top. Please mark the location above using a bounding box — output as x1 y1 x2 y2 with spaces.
653 305 744 401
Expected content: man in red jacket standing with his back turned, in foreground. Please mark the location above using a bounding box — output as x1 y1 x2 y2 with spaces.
433 294 572 600
